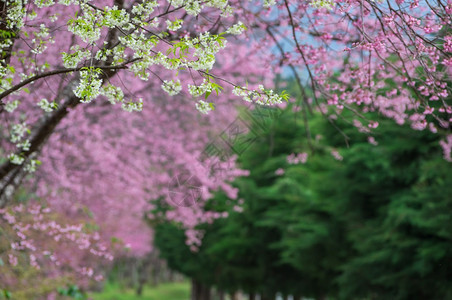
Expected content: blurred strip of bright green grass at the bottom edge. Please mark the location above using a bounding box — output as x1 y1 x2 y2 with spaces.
89 282 190 300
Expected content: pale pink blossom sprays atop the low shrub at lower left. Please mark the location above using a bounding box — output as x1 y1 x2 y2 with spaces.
0 204 113 278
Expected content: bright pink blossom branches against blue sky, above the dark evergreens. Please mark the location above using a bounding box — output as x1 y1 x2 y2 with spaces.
233 0 452 157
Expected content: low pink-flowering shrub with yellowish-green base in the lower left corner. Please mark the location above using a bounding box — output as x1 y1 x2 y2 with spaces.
0 203 116 298
